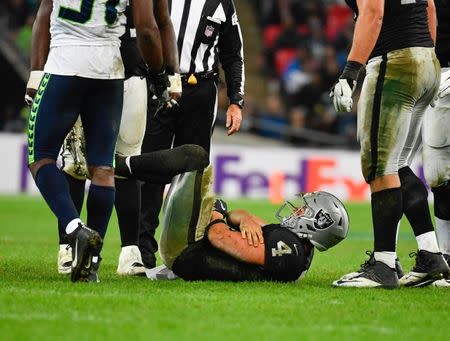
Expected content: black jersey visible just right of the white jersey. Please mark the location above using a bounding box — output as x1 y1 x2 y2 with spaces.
120 6 147 79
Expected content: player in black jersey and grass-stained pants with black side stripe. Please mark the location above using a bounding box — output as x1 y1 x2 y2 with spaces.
330 0 448 288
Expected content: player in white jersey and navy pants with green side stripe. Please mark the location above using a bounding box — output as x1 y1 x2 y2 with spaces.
26 0 163 281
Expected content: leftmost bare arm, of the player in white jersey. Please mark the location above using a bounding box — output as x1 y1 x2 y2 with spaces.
30 0 53 70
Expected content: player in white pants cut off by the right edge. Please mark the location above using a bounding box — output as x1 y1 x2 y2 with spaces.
406 0 450 287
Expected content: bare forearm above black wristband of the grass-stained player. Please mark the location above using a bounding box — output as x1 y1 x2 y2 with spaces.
348 0 384 64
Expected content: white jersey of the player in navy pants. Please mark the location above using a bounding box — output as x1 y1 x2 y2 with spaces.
44 0 128 79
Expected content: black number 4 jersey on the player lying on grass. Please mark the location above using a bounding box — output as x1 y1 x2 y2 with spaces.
172 224 314 282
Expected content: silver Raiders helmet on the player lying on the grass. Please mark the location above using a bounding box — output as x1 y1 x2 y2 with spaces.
275 191 349 251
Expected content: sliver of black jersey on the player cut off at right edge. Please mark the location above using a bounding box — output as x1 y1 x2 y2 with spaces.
434 0 450 67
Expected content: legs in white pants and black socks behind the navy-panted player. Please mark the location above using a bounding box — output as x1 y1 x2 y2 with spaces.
58 76 147 281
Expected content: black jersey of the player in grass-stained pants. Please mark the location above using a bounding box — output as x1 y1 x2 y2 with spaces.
345 0 434 58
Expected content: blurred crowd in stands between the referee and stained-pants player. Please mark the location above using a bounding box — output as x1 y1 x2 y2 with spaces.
246 0 356 145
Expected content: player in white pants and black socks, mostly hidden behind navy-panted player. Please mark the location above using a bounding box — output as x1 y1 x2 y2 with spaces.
51 0 178 278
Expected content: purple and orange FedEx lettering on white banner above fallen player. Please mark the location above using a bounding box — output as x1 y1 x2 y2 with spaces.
213 152 423 201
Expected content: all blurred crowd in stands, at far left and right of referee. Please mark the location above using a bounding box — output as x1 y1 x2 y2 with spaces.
0 0 356 146
